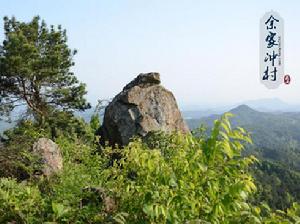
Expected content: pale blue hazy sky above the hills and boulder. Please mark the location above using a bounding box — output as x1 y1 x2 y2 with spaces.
0 0 300 107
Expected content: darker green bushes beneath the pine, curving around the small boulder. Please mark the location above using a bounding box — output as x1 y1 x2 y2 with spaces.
0 111 97 180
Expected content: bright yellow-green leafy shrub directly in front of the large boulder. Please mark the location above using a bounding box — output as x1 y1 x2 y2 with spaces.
102 115 256 223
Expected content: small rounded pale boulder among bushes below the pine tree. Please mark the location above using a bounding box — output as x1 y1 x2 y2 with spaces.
33 138 63 176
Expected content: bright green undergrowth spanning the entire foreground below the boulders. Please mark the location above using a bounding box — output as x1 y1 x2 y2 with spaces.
0 114 300 224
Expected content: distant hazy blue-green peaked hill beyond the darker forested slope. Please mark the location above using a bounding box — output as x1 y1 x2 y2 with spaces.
187 105 300 171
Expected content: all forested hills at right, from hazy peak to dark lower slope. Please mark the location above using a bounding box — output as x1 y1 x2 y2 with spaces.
187 105 300 209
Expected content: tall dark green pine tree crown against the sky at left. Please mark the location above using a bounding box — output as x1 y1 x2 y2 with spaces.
0 17 90 123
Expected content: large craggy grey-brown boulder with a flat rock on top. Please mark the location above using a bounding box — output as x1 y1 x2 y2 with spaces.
100 73 189 146
